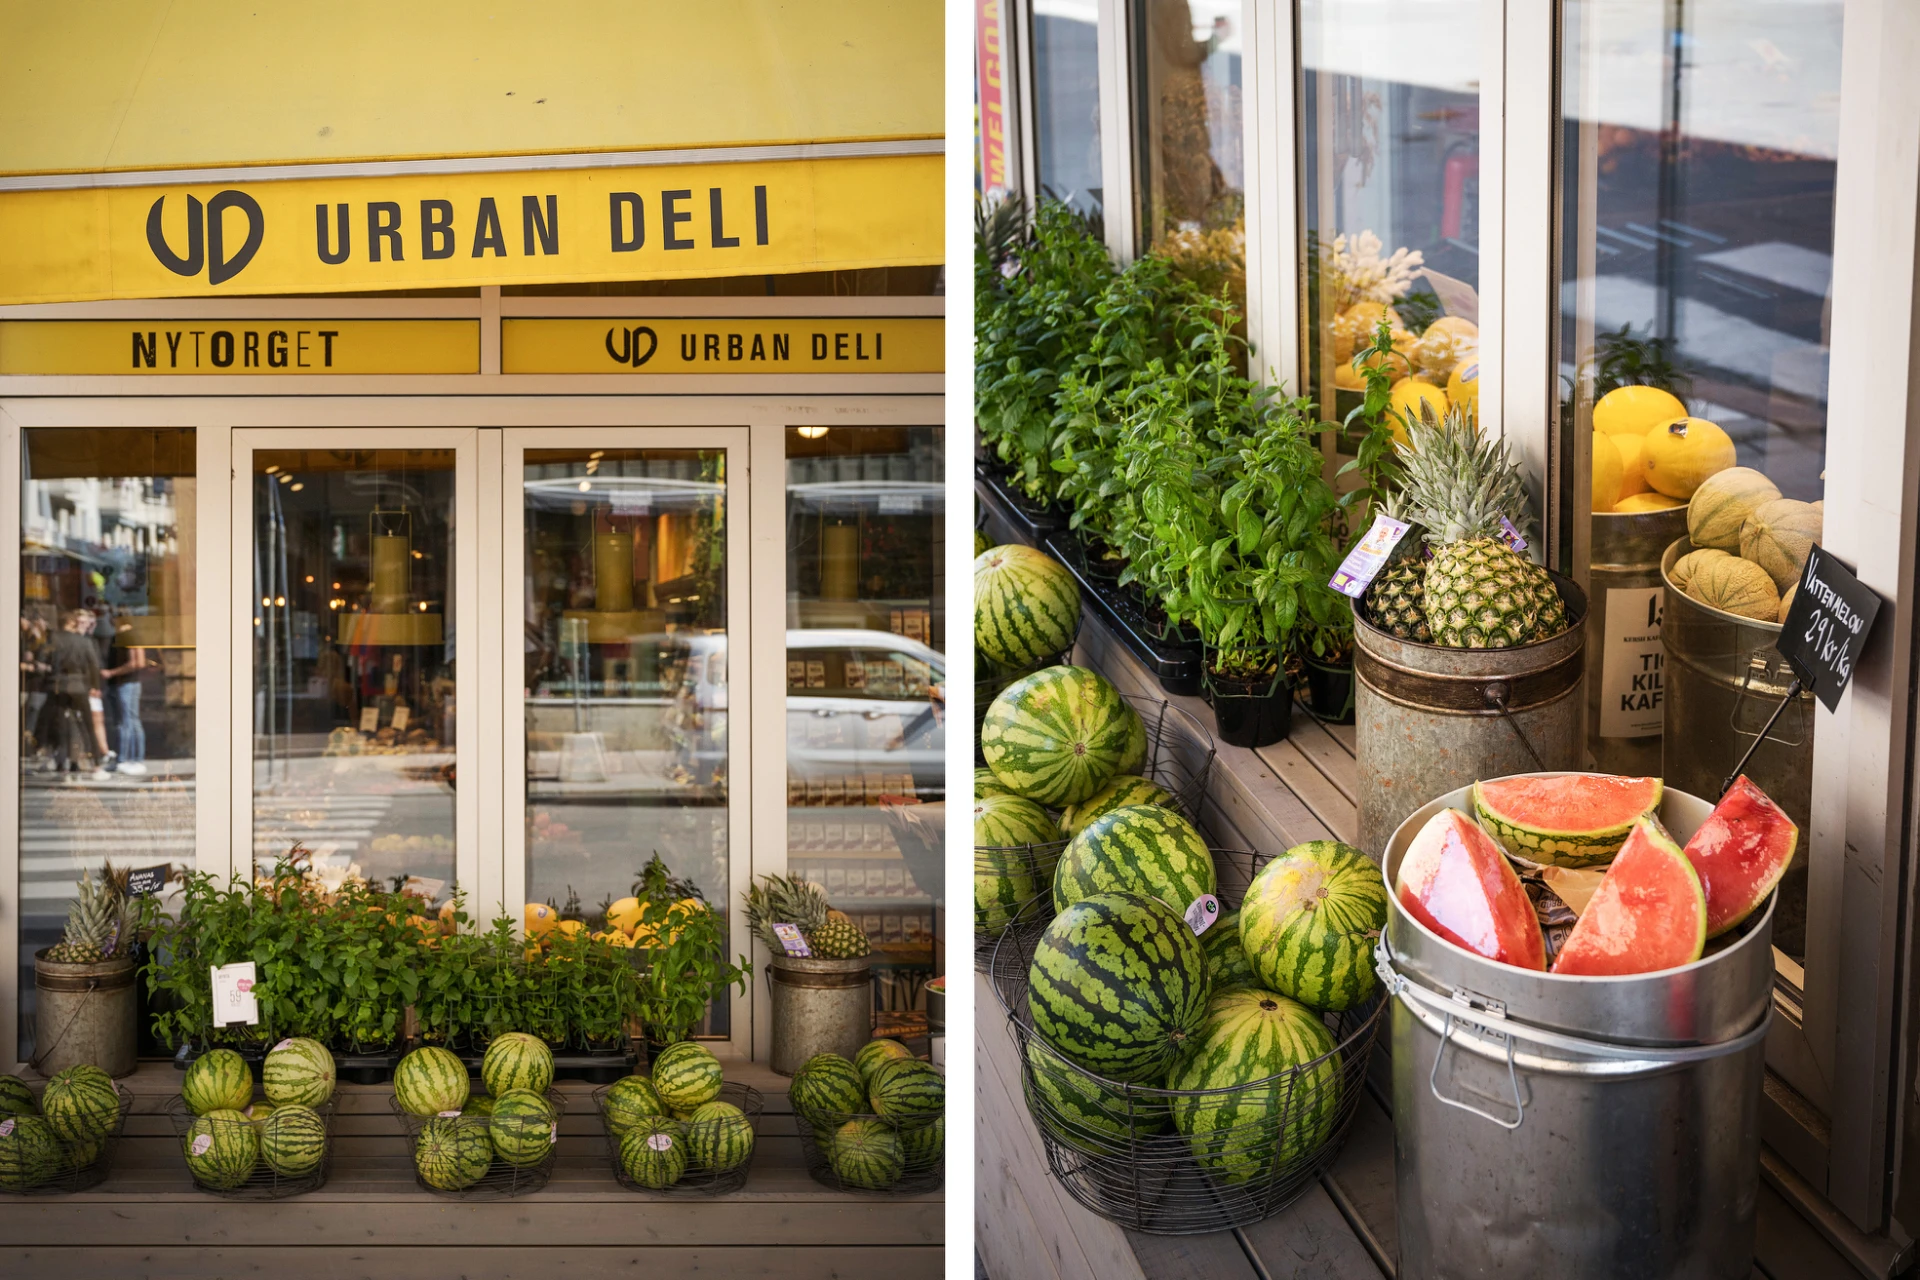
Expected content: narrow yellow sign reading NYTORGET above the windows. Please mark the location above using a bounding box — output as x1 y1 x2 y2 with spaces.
0 320 480 376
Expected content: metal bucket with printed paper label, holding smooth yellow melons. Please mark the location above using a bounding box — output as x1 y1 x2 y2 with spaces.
1586 507 1686 777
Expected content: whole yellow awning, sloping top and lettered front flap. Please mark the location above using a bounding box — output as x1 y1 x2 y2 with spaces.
0 0 943 303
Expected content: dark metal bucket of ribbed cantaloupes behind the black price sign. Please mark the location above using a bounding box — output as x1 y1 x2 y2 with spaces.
1661 537 1814 958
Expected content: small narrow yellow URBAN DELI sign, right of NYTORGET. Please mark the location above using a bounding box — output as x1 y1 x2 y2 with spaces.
499 317 947 374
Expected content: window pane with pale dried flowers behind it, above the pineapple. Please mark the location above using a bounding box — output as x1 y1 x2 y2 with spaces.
1300 0 1482 433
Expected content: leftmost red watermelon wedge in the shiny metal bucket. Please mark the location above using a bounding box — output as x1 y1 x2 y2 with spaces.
1394 810 1548 969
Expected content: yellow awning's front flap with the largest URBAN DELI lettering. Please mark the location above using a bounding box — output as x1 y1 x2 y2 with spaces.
0 155 945 305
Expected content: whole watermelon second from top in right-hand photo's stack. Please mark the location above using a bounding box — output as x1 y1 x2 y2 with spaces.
979 666 1140 808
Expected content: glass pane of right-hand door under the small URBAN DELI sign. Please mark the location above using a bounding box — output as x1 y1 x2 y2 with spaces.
520 449 730 1036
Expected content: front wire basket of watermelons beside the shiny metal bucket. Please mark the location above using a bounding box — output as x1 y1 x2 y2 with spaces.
993 850 1386 1236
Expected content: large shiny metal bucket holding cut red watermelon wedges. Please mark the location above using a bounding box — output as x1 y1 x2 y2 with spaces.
1377 789 1774 1280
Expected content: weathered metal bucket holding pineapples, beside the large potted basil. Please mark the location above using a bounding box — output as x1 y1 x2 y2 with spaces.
1354 574 1586 858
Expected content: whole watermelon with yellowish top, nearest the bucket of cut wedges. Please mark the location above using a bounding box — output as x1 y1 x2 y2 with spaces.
1215 841 1386 1011
